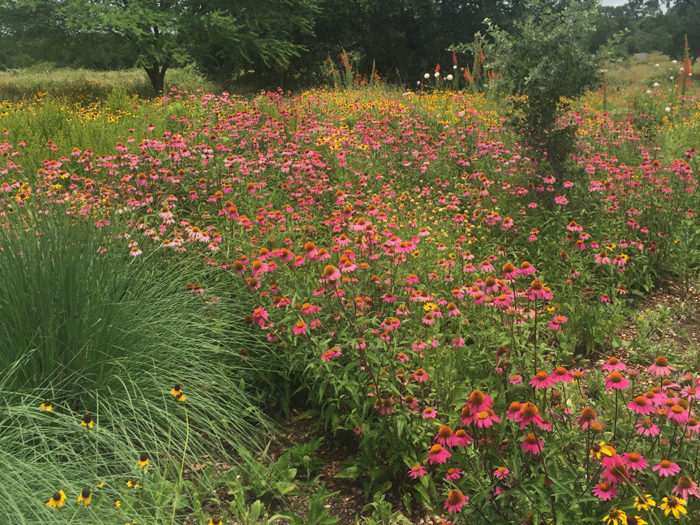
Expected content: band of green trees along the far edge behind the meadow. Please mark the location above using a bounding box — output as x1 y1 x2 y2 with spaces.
0 0 700 90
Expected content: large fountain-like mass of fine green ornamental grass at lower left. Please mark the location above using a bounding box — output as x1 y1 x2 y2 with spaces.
0 209 274 524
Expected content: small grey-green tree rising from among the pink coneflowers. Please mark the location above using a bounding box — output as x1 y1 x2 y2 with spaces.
478 0 599 168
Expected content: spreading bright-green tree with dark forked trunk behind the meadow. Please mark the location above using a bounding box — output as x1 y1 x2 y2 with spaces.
58 0 318 93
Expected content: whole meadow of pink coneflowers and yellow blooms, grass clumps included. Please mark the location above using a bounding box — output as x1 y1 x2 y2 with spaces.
0 49 700 525
